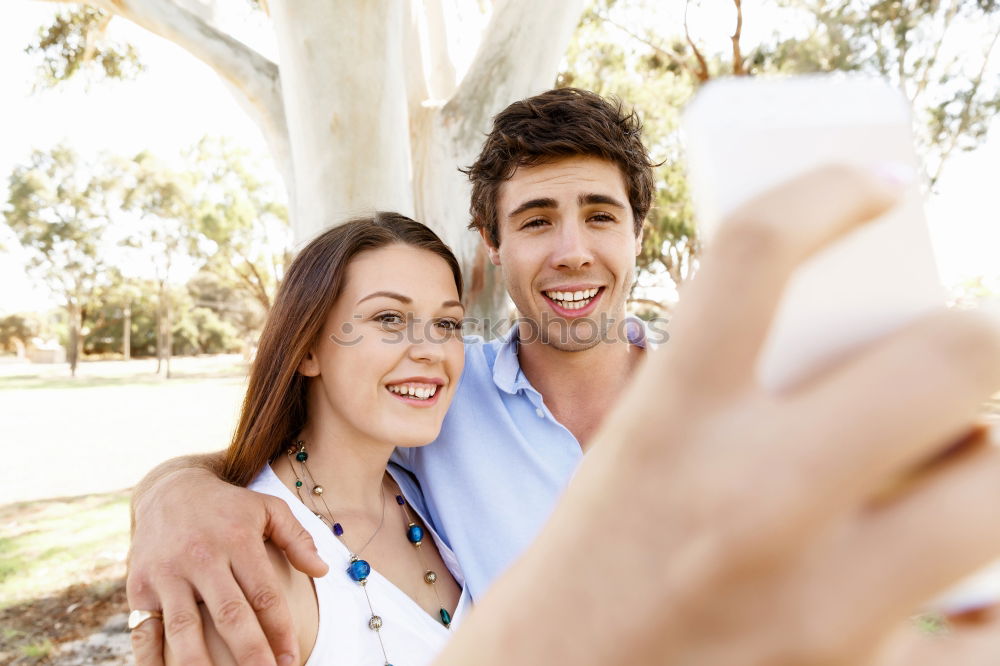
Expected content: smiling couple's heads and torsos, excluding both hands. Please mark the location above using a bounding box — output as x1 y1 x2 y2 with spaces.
129 89 653 666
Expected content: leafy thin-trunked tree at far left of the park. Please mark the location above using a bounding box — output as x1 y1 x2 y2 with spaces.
3 146 117 376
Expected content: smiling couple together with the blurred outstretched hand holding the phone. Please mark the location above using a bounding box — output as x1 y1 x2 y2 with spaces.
128 89 1000 666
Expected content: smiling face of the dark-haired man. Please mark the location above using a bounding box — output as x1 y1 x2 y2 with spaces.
490 157 641 351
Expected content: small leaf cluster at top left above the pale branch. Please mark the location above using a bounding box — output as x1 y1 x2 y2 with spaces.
25 5 143 87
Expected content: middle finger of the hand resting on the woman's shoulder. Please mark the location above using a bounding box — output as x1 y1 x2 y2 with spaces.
196 556 278 666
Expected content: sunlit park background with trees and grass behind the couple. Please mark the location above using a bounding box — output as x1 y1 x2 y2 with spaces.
0 0 1000 664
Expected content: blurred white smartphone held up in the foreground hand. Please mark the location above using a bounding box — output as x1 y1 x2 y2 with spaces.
681 74 1000 613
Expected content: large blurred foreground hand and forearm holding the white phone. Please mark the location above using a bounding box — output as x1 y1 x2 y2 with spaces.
438 163 1000 666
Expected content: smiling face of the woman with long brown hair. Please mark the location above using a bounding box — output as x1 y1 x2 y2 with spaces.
299 244 465 446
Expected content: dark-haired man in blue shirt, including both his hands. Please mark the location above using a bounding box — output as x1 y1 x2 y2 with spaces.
129 90 1000 664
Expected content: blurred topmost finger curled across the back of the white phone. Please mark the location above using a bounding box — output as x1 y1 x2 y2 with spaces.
668 166 901 392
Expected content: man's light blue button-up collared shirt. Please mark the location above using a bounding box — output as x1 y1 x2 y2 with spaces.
395 320 646 599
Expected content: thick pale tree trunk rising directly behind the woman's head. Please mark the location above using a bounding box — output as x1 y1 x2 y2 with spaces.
270 0 414 243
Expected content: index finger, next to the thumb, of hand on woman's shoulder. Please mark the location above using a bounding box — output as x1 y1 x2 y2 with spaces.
233 542 298 666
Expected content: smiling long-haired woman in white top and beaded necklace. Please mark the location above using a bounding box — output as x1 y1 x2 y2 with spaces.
167 213 468 666
